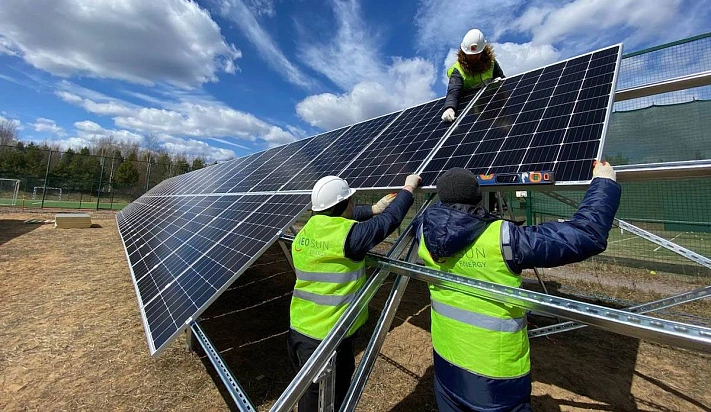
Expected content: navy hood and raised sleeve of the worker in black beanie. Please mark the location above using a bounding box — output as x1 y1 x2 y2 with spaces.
415 178 622 273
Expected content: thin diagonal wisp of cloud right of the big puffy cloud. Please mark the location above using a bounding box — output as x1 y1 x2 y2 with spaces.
213 0 314 88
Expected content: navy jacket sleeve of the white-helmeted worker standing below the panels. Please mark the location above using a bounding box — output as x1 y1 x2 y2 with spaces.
343 190 414 261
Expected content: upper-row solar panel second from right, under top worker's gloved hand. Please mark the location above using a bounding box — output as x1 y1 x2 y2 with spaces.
341 90 478 188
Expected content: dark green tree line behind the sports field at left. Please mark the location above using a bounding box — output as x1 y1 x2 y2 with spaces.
0 121 211 198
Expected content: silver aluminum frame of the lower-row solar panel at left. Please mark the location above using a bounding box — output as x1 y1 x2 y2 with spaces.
116 192 311 357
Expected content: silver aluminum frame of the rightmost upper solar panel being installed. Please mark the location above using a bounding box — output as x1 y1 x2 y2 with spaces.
420 43 622 192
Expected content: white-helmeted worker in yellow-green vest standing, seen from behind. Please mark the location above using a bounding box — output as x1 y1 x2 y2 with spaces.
288 175 421 412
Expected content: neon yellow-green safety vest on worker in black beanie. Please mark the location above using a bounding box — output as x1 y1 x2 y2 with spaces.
418 220 531 378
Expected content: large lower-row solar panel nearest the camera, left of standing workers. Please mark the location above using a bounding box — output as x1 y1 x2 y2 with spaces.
117 194 310 354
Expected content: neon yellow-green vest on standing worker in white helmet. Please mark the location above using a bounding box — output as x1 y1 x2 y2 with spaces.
290 215 368 340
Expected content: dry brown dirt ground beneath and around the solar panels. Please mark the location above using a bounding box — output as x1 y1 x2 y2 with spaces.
0 211 711 412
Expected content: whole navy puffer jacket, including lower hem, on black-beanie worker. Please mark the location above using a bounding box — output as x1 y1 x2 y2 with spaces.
414 178 622 412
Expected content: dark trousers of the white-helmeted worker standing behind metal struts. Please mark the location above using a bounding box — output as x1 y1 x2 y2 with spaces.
287 329 355 412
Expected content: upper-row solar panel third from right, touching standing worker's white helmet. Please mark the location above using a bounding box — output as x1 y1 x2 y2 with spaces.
281 112 400 190
